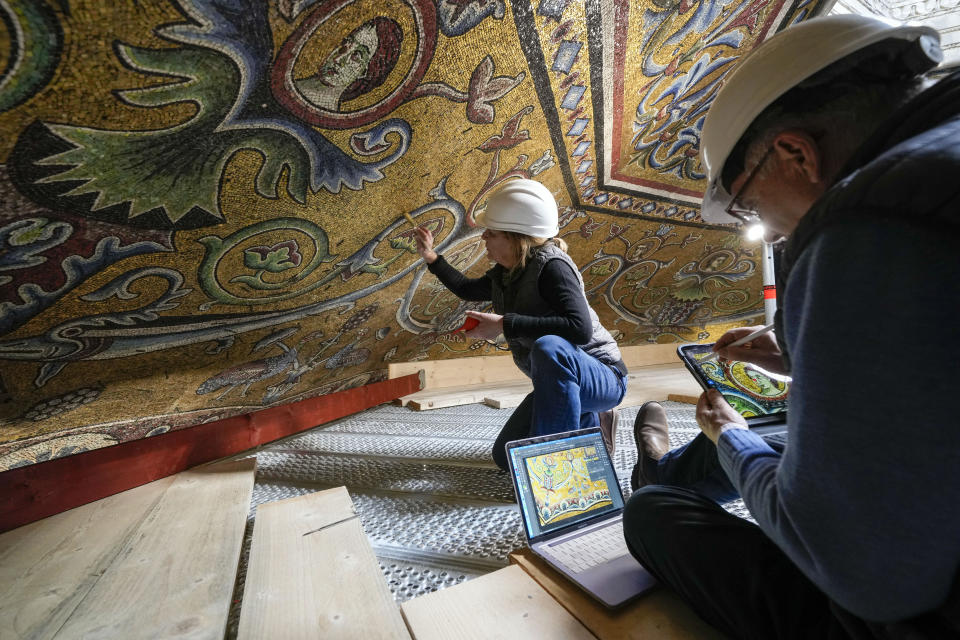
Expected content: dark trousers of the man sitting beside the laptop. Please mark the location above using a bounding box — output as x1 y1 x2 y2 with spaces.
623 434 850 640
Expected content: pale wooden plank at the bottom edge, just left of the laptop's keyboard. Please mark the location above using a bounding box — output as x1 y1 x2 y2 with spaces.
401 566 594 640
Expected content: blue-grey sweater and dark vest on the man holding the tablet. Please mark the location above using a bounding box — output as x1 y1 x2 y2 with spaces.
719 75 960 637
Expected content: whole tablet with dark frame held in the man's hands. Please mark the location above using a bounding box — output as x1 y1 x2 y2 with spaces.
677 343 790 427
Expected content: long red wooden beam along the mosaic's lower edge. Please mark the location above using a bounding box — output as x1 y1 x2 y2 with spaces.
0 374 421 531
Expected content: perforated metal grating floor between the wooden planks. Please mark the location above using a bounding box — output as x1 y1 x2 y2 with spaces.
226 402 746 638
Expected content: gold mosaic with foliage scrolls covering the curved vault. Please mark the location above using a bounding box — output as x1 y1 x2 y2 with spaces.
0 0 817 470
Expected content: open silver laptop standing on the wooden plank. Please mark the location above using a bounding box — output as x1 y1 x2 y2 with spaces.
507 427 656 607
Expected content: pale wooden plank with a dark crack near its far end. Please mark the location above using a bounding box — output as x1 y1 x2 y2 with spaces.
238 487 410 640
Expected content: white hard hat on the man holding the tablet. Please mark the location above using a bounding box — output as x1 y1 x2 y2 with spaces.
700 14 943 223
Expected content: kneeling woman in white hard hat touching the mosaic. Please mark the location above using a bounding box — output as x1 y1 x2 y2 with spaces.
417 179 627 469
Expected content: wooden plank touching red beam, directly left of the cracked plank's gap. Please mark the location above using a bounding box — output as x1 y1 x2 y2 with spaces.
57 459 256 640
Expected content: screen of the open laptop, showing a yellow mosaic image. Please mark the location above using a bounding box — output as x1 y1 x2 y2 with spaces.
508 431 623 538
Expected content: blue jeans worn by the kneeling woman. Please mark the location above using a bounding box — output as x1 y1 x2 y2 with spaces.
493 335 627 470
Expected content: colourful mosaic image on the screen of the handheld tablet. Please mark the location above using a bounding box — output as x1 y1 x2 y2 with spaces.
687 345 790 418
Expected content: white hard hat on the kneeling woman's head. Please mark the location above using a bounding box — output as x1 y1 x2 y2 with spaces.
476 178 560 238
